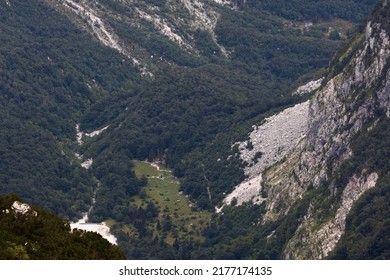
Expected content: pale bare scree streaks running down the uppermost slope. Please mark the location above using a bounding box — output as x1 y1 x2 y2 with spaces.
50 0 230 63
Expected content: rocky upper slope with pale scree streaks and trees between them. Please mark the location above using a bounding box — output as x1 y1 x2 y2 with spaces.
45 0 235 74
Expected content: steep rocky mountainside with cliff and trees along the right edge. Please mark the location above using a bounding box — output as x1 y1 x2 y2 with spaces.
193 1 390 259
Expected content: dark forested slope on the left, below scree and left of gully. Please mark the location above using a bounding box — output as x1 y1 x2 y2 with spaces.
0 1 140 218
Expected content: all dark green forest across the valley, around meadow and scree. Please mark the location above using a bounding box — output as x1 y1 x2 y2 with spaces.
0 0 388 259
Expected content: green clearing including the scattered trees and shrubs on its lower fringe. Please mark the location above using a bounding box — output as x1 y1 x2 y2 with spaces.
109 161 211 256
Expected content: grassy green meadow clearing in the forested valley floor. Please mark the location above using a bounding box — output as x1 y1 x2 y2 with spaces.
111 161 211 244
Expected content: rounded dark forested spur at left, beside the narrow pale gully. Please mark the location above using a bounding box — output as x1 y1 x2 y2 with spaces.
0 112 94 217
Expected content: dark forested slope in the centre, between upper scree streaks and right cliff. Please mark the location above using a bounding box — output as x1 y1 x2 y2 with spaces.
81 1 373 217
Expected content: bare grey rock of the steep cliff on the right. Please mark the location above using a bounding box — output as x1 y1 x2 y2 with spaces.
263 1 390 259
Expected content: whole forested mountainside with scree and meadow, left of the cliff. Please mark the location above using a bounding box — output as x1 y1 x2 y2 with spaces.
0 0 384 258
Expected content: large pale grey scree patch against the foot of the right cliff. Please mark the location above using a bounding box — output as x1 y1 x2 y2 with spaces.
216 101 310 212
